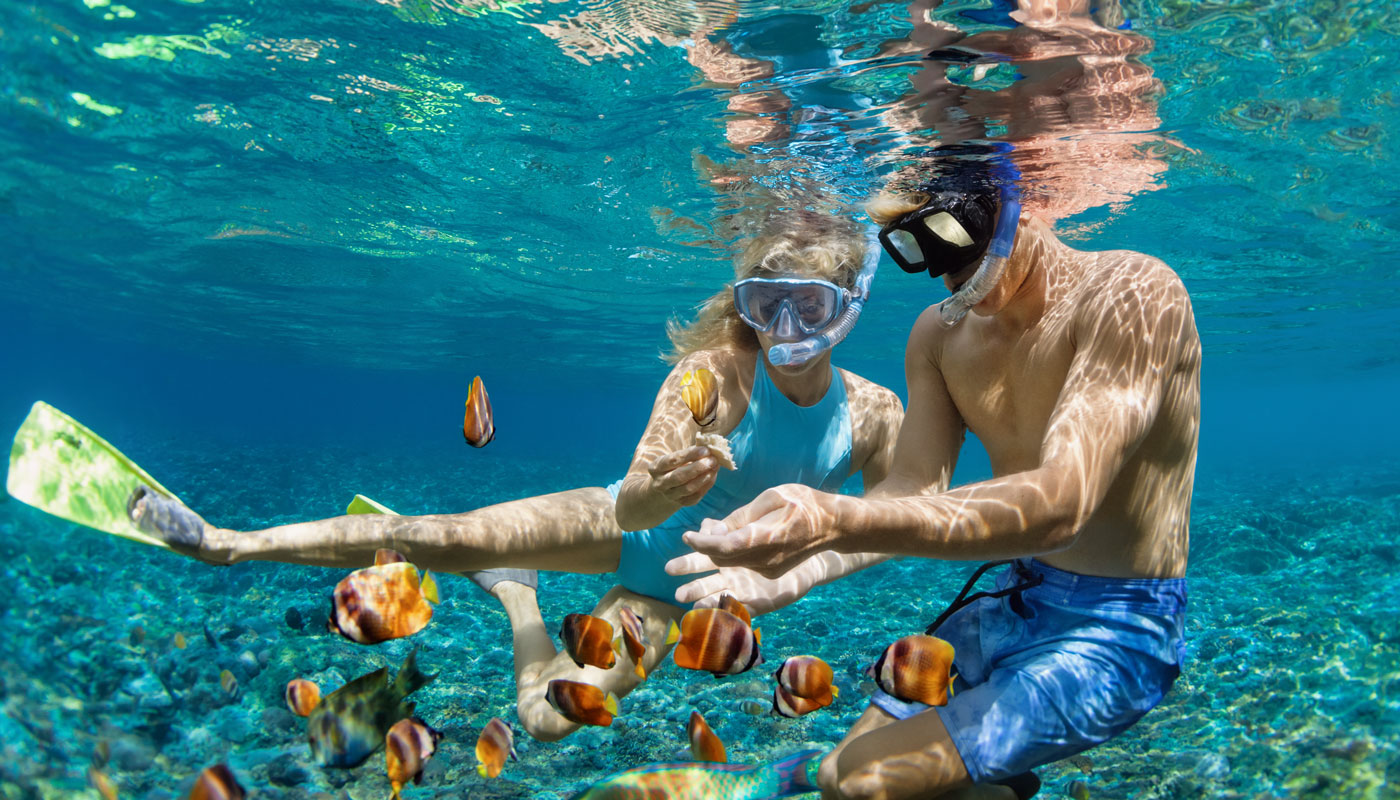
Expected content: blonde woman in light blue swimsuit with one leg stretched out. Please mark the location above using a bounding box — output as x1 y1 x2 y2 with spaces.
132 212 903 741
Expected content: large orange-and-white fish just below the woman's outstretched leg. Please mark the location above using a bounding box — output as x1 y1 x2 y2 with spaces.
326 562 438 644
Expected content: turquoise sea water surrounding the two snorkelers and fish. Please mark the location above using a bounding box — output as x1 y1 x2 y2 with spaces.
0 0 1400 799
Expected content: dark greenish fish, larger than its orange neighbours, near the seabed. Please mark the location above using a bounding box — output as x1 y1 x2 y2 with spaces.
307 650 435 766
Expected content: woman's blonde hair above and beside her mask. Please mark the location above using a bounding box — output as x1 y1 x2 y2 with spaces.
665 210 867 364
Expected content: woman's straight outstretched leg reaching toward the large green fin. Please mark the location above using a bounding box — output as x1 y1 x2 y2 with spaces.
146 486 622 573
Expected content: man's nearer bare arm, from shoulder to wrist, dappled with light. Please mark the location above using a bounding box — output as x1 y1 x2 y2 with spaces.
829 265 1194 559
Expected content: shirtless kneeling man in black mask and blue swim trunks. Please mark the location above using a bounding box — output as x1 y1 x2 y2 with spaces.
668 152 1201 799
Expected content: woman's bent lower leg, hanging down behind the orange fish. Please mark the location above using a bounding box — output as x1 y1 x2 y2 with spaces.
506 583 683 741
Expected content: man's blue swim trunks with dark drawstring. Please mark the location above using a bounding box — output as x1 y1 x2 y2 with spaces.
871 559 1186 783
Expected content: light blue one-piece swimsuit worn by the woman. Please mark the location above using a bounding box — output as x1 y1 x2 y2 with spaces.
608 356 851 602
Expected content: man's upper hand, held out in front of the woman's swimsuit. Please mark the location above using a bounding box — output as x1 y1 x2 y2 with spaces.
666 483 836 579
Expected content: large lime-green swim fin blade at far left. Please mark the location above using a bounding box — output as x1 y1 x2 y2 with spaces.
6 401 178 549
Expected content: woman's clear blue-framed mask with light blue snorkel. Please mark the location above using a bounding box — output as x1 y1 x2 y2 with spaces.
734 228 881 367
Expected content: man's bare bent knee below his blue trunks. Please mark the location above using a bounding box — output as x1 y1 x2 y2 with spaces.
818 705 1016 800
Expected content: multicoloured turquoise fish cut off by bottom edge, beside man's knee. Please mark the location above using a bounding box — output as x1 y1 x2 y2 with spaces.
573 750 823 800
